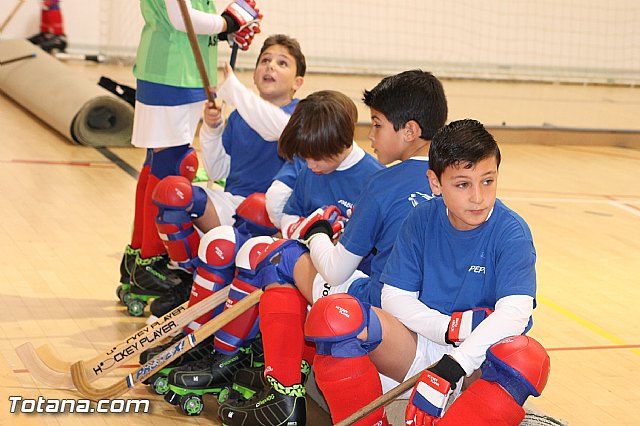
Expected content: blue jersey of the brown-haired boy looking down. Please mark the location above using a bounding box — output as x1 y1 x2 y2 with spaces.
284 153 384 217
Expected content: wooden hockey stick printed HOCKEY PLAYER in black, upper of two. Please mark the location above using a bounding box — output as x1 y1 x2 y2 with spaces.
16 286 230 389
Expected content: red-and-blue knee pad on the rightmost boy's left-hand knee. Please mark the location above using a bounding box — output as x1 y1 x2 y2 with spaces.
304 293 382 358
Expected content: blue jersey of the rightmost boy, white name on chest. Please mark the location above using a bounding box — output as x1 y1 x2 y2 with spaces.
381 197 536 320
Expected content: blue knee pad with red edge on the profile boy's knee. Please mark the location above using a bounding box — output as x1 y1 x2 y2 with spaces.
256 239 309 287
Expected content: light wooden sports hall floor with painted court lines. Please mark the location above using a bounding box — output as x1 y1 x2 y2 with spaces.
0 60 640 425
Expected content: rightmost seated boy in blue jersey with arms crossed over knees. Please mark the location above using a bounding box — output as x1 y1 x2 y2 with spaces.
305 120 549 425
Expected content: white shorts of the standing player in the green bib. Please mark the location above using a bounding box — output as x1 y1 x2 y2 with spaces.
131 101 203 148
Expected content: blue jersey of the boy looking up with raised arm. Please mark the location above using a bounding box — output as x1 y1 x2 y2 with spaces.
222 99 299 197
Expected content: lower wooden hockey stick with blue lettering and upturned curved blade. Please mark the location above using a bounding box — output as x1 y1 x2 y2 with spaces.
71 290 262 401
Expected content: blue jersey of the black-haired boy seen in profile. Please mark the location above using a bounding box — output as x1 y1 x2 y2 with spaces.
340 159 433 307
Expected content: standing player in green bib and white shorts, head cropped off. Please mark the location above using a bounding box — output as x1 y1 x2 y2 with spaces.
118 0 261 310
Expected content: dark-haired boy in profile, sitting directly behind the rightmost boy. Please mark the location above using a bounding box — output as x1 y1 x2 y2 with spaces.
218 74 447 426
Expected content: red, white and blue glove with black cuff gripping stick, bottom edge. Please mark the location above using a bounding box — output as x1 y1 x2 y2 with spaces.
405 355 465 426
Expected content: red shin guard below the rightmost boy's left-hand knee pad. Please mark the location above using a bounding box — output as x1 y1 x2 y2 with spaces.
313 355 387 426
